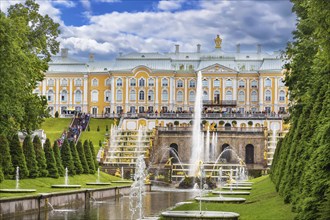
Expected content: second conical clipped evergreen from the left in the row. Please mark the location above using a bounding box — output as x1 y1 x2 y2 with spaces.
9 134 29 179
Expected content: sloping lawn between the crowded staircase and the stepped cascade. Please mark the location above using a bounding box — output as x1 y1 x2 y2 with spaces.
80 118 113 151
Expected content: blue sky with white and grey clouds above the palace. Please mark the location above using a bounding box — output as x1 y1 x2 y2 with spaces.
0 0 296 60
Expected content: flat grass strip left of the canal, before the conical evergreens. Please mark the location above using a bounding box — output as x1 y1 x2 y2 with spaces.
0 172 129 198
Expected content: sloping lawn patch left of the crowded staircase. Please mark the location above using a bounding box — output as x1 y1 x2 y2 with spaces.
41 118 72 144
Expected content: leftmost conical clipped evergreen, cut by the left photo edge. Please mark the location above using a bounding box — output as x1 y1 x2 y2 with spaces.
0 134 14 179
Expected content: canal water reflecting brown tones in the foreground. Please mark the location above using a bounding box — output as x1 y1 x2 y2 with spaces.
9 191 196 220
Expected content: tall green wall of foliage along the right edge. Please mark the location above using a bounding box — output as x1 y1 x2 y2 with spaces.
271 0 330 219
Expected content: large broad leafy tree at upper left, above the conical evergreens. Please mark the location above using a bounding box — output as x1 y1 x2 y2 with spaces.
0 0 60 135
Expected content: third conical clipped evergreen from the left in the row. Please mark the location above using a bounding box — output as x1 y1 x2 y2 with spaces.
23 135 39 178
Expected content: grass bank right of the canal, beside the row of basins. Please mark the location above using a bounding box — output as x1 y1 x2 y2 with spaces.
169 176 295 220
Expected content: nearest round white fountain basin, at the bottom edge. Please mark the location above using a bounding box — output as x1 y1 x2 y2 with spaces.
162 211 239 219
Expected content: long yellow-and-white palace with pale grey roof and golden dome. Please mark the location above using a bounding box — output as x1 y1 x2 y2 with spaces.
34 36 288 117
